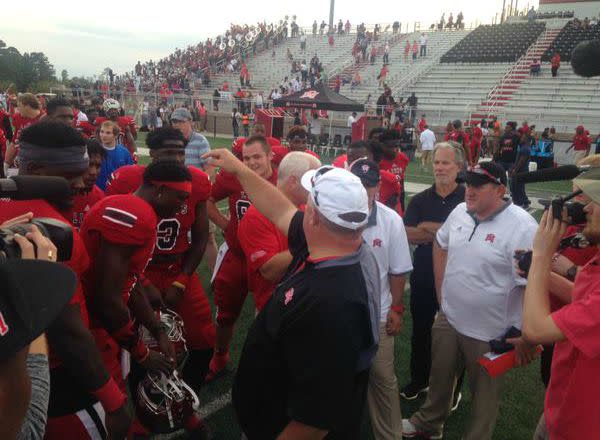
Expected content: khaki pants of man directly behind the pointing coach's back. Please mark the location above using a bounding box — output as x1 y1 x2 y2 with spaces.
367 323 402 440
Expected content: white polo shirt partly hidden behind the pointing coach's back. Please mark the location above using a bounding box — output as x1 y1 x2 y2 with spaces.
363 202 412 322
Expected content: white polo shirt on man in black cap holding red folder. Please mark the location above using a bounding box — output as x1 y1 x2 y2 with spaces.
436 202 537 342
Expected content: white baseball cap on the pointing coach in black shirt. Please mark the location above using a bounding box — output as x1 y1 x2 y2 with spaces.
301 165 369 230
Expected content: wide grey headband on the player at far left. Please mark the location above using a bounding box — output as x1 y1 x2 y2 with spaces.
17 142 89 173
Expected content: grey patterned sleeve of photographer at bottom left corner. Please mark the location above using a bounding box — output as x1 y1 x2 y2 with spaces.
17 354 50 440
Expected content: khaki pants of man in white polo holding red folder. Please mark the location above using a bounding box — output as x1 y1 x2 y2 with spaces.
410 312 504 440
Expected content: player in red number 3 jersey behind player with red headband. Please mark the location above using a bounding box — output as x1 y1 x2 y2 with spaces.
107 127 215 392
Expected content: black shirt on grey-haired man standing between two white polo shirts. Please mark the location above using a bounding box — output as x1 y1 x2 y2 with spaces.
403 184 465 286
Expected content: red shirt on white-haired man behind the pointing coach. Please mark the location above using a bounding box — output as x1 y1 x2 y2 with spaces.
238 206 288 310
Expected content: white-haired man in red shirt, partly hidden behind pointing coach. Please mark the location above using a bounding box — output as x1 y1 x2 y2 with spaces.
238 151 321 311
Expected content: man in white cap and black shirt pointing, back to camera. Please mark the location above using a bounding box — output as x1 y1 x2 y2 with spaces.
206 150 380 440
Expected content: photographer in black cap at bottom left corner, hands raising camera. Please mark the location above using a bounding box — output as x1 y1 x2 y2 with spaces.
0 220 76 440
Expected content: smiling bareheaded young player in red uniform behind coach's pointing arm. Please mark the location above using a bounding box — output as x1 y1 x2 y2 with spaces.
206 136 277 380
